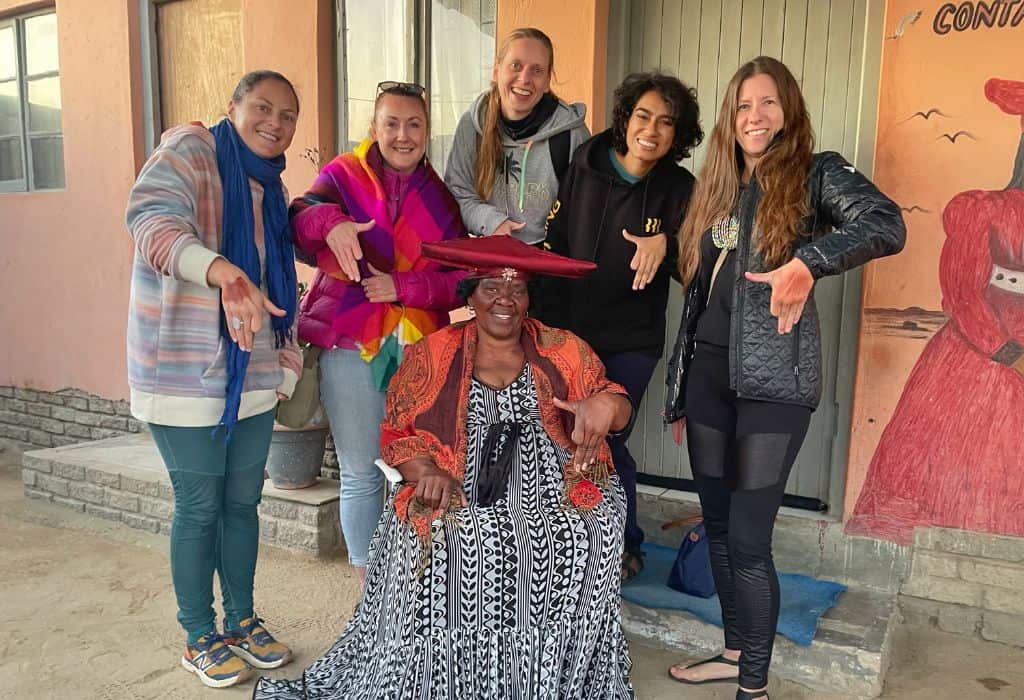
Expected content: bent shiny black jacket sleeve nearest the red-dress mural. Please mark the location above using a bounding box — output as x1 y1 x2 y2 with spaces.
795 151 906 279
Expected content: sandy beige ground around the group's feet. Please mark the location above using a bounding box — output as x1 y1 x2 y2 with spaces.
0 445 1024 700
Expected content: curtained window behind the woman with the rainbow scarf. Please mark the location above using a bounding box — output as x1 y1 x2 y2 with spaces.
338 0 497 167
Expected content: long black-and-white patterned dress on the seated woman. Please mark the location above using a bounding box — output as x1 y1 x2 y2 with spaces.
254 363 634 700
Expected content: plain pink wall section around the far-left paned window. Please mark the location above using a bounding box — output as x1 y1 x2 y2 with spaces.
0 0 138 398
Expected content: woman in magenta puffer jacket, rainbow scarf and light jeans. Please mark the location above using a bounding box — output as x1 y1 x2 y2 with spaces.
290 81 466 581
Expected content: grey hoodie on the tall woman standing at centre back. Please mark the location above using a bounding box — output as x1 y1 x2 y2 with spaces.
444 92 590 244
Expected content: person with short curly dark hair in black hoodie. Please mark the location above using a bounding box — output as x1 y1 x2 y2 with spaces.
537 73 703 580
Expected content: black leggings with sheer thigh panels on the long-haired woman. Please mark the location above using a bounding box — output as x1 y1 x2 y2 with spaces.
686 343 811 689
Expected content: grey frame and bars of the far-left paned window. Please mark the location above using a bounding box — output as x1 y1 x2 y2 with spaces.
0 5 68 193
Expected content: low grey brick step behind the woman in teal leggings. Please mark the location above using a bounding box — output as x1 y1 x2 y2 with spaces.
22 433 343 557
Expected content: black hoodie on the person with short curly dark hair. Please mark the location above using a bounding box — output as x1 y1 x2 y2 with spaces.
535 129 694 357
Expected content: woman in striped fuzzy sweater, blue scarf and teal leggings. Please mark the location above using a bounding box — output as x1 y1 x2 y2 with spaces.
127 71 302 688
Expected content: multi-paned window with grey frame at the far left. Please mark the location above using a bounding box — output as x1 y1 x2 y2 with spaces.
0 10 65 191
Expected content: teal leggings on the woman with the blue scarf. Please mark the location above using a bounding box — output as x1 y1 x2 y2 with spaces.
150 410 273 645
